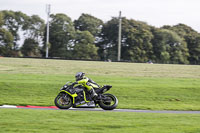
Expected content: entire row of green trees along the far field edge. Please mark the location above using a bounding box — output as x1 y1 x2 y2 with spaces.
0 10 200 64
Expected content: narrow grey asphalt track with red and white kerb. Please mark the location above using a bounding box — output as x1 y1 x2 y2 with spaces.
0 105 200 114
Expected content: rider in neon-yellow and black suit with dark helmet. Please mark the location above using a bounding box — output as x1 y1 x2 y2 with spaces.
73 72 100 99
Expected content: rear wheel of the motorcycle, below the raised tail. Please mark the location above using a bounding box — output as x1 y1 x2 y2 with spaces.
99 94 118 110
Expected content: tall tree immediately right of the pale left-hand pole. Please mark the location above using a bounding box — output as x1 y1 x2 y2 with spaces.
48 14 75 58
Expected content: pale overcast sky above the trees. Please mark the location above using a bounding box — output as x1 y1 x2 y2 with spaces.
0 0 200 32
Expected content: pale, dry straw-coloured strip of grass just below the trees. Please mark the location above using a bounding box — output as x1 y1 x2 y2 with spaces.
0 58 200 78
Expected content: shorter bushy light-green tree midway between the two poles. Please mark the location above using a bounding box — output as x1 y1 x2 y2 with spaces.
73 31 98 60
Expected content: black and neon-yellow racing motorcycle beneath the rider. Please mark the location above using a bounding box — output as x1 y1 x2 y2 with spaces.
54 82 118 110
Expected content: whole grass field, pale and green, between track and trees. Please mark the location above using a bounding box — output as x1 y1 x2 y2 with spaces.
0 58 200 110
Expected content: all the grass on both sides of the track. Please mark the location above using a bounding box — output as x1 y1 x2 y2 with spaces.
0 58 200 133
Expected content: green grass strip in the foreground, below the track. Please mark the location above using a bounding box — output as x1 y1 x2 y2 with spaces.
0 109 200 133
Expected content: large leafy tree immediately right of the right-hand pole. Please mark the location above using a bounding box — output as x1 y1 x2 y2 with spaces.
122 19 153 62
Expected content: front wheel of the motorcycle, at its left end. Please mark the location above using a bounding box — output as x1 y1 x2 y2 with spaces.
54 93 72 109
